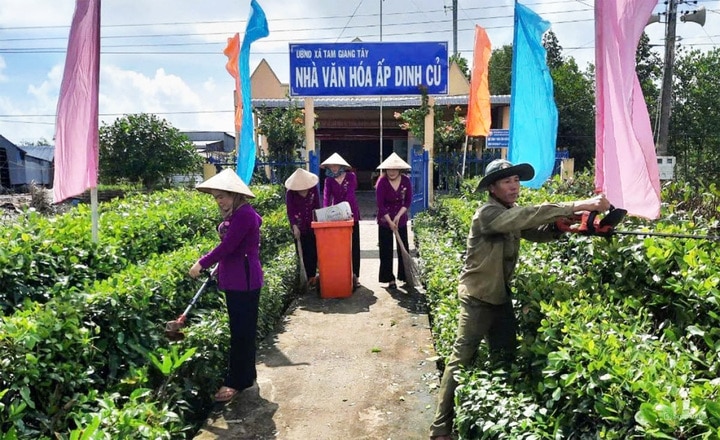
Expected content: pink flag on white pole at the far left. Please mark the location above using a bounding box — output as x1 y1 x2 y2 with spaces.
53 0 100 203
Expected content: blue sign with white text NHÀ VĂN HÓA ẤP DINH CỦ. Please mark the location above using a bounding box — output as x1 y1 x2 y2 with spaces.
290 42 448 96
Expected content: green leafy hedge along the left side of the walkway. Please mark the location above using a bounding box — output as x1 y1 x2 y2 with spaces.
0 187 298 439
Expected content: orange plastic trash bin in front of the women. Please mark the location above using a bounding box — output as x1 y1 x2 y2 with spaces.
311 220 355 298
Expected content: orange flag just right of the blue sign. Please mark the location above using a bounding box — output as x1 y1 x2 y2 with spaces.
465 25 492 136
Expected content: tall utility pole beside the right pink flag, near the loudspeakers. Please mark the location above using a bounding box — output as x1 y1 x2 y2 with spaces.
656 0 677 156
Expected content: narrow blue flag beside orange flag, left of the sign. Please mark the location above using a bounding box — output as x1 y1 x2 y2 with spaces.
237 0 270 185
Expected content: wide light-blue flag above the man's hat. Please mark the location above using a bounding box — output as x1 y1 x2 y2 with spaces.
508 2 558 188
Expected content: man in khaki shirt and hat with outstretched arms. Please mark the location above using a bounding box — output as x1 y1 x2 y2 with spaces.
430 159 610 440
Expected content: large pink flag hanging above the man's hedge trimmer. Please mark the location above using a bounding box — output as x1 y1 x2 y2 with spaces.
595 0 660 219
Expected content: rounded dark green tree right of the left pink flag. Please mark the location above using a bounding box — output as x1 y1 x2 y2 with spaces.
100 113 202 189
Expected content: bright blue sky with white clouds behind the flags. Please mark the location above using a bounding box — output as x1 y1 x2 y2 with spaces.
0 0 720 144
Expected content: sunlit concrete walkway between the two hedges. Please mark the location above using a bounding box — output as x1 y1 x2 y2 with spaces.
195 208 439 440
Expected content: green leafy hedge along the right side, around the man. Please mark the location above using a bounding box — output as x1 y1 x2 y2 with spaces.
413 178 720 439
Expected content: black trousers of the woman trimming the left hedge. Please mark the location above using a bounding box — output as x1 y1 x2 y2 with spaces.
224 289 260 390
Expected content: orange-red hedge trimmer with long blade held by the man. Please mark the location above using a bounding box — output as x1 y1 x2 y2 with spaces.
555 206 720 240
